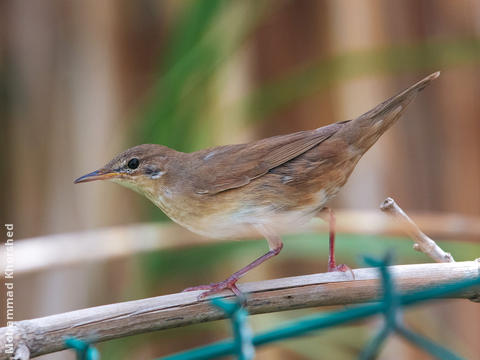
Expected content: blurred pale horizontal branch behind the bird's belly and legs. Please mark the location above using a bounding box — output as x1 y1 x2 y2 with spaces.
4 210 480 276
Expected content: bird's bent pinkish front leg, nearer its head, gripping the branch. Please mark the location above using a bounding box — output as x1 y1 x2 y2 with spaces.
183 229 283 299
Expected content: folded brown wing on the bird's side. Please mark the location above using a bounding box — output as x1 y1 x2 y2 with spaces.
191 122 345 194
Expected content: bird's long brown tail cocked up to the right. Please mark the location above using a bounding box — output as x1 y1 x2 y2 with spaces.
336 71 440 152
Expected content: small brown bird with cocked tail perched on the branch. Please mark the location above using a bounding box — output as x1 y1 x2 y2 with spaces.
75 72 440 297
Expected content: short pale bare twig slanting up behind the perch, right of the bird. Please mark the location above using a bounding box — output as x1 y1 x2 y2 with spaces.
380 197 455 262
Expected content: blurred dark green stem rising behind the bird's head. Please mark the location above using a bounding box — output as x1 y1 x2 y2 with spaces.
142 0 225 150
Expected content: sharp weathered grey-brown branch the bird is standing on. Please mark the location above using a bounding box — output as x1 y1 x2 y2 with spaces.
0 259 480 359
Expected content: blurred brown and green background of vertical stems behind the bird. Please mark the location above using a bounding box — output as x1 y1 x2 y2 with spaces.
0 0 480 359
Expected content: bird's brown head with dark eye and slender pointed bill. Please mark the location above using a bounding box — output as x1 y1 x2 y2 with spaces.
74 144 174 193
